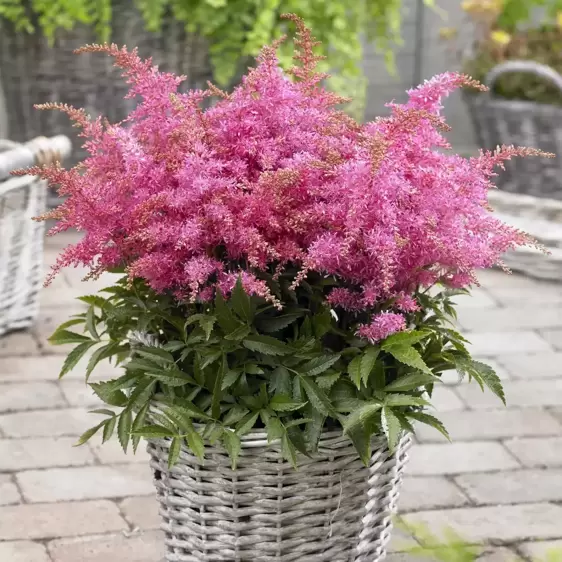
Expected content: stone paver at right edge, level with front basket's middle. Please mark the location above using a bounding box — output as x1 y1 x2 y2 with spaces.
455 469 562 505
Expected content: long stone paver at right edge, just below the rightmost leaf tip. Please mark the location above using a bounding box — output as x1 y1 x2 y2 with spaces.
416 406 562 442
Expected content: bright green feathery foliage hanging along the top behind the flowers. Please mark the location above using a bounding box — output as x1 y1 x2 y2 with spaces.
0 0 433 116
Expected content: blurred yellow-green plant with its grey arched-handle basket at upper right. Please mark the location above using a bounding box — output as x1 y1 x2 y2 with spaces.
443 0 562 200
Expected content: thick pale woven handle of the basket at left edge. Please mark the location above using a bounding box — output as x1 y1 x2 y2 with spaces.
0 135 72 181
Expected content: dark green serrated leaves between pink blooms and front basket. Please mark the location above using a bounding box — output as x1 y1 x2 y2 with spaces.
50 276 504 464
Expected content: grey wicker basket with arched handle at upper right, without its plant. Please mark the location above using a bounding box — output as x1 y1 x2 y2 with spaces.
465 61 562 200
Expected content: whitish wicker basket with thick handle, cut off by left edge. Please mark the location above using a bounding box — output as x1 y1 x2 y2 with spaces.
0 137 70 336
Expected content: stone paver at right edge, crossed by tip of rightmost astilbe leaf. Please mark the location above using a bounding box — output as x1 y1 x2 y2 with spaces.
455 378 562 409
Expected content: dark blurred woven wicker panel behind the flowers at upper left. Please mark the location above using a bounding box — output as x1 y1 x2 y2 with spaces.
0 0 212 164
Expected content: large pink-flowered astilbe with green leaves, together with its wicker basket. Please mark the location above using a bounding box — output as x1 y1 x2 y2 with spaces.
20 15 539 562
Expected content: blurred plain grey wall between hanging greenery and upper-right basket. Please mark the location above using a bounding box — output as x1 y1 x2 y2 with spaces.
364 0 475 152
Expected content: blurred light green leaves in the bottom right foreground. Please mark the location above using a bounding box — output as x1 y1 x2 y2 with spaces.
395 519 562 562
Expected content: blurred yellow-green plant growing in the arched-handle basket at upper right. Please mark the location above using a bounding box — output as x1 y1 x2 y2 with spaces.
441 0 562 105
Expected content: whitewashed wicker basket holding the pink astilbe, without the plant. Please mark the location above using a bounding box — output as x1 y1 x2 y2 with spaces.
148 426 411 562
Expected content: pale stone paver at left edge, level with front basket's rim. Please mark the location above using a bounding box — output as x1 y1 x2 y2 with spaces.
0 437 95 472
